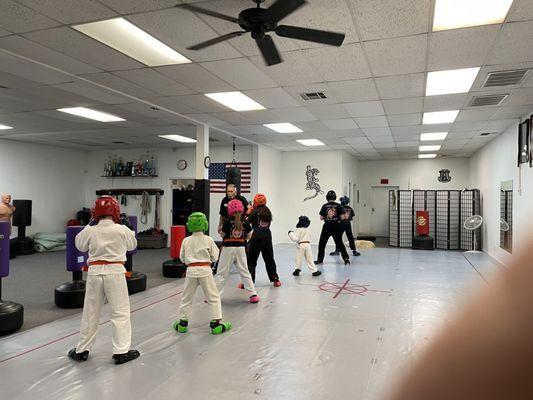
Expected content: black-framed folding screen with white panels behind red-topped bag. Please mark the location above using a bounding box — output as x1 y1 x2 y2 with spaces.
389 189 481 250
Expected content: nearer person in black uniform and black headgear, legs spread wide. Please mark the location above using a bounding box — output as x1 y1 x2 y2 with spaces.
315 190 350 264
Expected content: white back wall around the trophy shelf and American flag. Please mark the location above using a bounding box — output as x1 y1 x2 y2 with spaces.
84 146 253 240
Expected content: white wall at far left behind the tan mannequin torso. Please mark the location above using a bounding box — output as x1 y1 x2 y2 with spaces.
0 140 87 236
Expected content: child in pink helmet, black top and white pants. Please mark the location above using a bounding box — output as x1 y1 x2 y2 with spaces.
215 199 259 303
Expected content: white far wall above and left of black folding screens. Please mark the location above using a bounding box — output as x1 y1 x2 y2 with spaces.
356 158 468 233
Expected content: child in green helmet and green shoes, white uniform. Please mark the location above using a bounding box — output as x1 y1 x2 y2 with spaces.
174 212 231 335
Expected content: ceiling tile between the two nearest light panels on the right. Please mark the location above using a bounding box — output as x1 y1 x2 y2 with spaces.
428 24 501 71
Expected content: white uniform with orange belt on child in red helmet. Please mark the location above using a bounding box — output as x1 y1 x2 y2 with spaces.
76 219 137 354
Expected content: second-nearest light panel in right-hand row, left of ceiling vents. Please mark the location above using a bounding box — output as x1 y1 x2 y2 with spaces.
426 67 479 96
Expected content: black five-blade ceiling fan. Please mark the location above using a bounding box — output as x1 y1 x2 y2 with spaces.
177 0 345 65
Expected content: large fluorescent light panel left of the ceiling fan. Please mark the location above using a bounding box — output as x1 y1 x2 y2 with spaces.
72 18 191 67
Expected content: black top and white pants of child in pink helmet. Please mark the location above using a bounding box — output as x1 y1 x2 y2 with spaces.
215 222 257 297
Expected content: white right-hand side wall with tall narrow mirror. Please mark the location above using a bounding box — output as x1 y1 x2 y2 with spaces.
470 109 533 264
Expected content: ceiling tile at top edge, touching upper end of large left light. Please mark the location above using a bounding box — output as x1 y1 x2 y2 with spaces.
17 0 117 24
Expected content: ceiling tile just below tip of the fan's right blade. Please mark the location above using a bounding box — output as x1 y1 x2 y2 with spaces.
302 43 371 81
